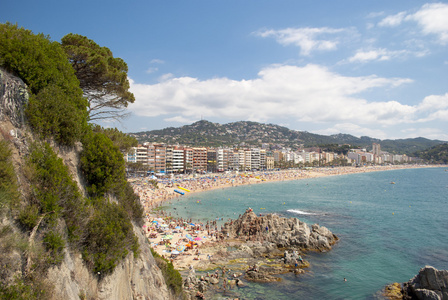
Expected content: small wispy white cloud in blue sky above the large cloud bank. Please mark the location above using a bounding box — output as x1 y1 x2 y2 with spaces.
254 27 347 56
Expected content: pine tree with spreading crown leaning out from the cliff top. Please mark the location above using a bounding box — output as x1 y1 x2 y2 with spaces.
61 33 135 121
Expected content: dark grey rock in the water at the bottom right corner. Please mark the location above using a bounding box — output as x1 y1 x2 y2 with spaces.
403 266 448 300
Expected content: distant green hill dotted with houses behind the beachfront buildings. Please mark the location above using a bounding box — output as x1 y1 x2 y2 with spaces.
130 120 443 154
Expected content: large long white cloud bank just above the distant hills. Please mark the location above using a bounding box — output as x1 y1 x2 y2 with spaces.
130 64 416 125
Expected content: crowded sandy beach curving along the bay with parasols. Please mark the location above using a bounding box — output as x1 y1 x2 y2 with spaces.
129 165 443 270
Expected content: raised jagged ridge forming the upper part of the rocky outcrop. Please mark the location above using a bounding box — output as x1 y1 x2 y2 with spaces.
222 209 338 251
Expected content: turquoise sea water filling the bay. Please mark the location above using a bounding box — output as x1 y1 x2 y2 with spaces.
164 168 448 299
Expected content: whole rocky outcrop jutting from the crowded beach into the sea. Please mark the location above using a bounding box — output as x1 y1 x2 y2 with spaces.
180 208 338 299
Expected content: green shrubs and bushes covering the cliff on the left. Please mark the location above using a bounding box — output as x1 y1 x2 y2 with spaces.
0 24 143 299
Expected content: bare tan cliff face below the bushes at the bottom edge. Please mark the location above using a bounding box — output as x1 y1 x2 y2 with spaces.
47 226 173 300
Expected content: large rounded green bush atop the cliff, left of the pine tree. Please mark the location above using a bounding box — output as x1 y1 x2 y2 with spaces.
0 23 88 145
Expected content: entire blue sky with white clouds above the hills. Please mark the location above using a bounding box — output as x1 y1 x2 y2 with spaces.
0 0 448 141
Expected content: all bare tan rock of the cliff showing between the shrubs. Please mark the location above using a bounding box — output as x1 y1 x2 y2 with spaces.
0 69 175 300
